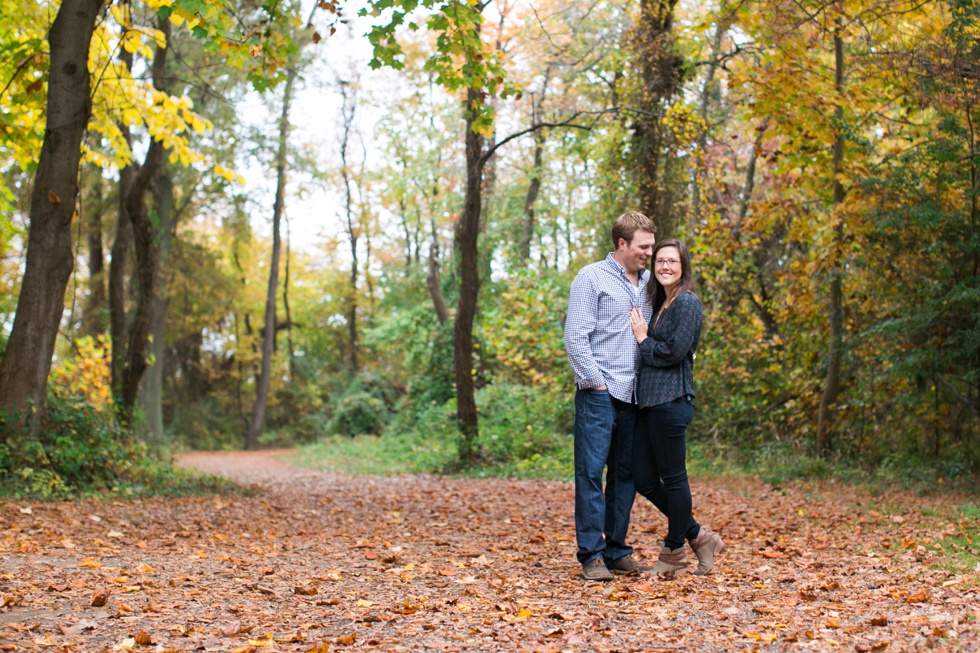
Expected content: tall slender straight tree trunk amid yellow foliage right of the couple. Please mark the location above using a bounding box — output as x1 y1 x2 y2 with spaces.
817 18 844 456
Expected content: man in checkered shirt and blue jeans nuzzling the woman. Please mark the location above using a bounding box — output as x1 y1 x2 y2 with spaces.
565 211 656 580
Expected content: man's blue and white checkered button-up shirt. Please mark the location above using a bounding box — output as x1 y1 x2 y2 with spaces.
565 252 653 403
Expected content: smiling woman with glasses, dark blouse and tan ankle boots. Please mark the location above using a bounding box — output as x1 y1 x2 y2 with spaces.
630 240 725 578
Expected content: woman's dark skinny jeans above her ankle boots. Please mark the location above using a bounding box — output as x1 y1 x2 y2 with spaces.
633 397 701 551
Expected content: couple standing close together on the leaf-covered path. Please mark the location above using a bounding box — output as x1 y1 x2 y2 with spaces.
565 211 725 580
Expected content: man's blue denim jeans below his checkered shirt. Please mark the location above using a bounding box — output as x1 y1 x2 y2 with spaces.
575 390 636 566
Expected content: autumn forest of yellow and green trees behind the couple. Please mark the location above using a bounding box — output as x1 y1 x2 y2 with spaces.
0 0 980 496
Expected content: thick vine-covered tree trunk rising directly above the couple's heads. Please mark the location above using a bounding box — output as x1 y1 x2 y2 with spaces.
633 0 683 239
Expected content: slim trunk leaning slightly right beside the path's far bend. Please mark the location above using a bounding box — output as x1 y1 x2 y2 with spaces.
245 67 296 451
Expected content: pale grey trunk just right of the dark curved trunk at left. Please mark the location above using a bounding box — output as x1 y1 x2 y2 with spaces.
140 165 174 441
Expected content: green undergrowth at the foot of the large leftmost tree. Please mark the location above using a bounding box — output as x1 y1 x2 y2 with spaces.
0 398 237 499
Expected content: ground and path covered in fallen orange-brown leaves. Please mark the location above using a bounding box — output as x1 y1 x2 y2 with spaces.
0 453 980 651
